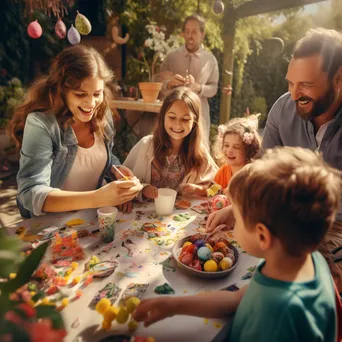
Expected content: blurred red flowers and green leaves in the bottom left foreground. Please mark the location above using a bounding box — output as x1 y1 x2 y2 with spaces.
0 229 66 342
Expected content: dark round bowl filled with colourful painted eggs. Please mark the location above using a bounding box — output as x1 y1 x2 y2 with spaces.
172 234 239 278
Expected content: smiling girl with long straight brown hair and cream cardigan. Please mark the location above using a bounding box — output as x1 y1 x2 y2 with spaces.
124 87 218 199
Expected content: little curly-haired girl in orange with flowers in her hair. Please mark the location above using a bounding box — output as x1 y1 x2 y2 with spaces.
213 115 261 189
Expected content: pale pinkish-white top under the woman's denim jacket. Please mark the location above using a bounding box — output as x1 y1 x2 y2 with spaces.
62 134 107 191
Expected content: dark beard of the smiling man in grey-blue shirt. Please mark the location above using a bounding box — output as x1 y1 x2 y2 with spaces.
296 83 335 121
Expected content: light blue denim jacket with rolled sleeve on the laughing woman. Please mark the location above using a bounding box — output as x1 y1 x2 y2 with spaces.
17 112 120 218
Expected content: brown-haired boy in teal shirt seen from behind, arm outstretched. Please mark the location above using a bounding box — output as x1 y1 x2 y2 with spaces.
134 147 341 342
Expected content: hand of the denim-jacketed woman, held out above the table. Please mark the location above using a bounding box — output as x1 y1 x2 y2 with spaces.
95 177 143 208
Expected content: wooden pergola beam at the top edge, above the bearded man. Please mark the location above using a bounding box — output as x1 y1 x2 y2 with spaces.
234 0 326 20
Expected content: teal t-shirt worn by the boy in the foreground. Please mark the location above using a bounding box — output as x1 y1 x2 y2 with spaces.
229 252 337 342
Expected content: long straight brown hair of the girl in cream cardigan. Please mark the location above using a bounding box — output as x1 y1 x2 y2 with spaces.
153 87 207 174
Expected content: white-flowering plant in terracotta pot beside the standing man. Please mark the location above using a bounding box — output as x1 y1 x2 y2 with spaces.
134 24 180 102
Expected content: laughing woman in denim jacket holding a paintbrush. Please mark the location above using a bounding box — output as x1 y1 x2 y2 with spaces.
8 45 142 218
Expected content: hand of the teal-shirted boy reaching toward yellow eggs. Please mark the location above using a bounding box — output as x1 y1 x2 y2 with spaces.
133 298 175 327
